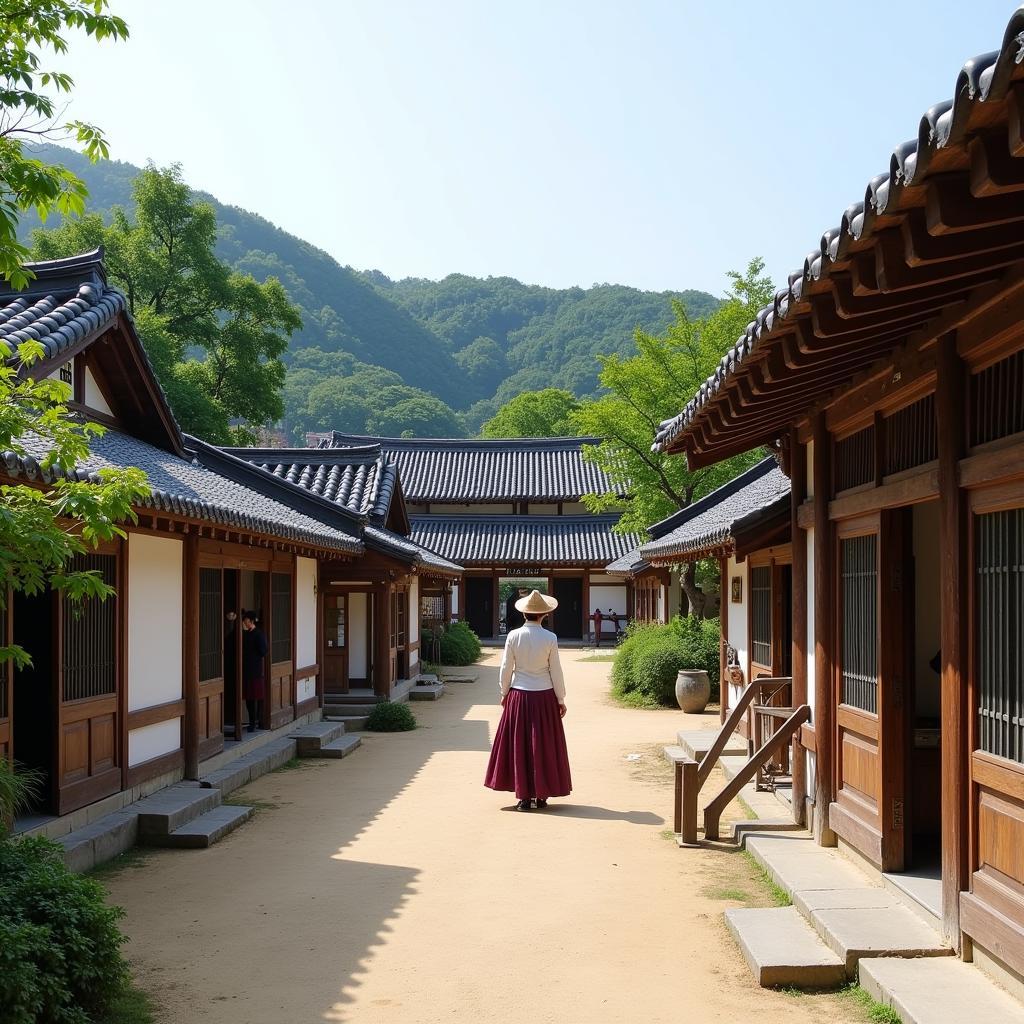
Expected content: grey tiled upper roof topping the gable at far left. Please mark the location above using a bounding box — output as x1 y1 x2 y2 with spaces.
0 250 127 359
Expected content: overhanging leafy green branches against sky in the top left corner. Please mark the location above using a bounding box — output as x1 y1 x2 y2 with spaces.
0 0 128 288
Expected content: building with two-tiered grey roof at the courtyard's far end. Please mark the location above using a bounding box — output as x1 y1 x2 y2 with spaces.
309 432 636 639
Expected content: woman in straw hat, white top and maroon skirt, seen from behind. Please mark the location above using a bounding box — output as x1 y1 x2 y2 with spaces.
483 590 572 811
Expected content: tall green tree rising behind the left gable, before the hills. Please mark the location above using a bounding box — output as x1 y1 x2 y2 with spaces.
33 165 302 443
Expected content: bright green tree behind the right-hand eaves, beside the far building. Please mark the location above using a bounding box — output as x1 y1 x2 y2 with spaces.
572 259 774 610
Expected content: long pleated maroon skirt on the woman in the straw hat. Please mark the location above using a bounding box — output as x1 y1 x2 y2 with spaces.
483 687 572 800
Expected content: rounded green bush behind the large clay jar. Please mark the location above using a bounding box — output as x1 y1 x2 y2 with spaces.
611 616 720 708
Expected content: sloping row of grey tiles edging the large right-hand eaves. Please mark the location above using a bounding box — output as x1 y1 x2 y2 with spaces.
653 6 1024 451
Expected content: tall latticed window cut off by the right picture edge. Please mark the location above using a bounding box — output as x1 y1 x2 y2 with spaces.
975 509 1024 763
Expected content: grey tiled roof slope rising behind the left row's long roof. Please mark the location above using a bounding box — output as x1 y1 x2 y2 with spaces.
224 444 397 521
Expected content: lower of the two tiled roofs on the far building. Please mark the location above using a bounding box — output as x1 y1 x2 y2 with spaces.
410 515 637 566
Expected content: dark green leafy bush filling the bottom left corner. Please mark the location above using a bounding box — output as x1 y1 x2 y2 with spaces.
0 839 129 1024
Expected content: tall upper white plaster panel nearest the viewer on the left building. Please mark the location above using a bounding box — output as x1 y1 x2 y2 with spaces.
127 534 184 712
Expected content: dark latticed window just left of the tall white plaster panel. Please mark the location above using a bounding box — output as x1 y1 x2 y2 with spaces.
62 554 118 700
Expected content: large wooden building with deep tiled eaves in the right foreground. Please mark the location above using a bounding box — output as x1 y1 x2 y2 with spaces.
656 9 1024 979
